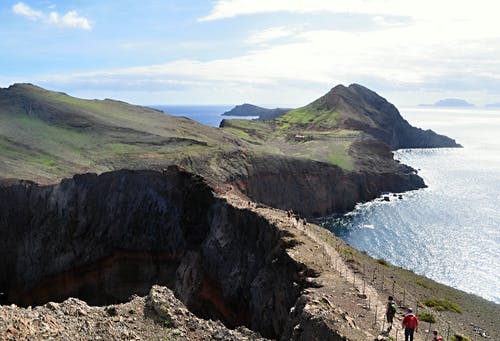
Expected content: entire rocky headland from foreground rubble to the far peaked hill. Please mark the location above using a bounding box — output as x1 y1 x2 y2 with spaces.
0 84 492 340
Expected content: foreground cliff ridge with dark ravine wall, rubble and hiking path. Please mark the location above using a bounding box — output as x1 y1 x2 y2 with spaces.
0 167 498 341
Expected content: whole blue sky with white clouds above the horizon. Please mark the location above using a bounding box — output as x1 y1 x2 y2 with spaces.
0 0 500 107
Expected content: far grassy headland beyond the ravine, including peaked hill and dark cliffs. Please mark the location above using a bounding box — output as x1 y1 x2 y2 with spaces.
0 84 455 216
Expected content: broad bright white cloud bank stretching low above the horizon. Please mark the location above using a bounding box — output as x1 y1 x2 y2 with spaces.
37 13 500 105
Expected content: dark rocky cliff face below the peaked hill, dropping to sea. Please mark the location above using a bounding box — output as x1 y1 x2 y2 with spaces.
233 153 425 217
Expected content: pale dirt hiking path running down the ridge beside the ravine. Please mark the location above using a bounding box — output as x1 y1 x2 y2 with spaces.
225 193 446 341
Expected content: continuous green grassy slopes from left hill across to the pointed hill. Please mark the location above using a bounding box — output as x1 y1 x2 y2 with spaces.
0 84 430 183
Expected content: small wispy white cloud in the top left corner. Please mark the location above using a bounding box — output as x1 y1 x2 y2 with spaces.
12 2 92 30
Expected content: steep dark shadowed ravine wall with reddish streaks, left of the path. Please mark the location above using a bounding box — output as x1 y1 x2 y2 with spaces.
0 168 307 338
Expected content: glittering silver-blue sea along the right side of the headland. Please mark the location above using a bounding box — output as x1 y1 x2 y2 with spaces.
321 108 500 303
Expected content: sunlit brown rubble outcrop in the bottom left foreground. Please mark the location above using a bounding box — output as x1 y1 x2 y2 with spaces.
0 286 265 341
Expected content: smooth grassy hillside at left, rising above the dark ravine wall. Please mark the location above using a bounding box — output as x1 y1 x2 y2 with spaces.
0 84 244 182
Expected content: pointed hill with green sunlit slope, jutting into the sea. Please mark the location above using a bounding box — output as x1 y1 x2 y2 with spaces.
221 84 459 171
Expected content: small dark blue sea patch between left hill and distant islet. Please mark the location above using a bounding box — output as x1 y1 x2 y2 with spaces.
151 105 258 127
